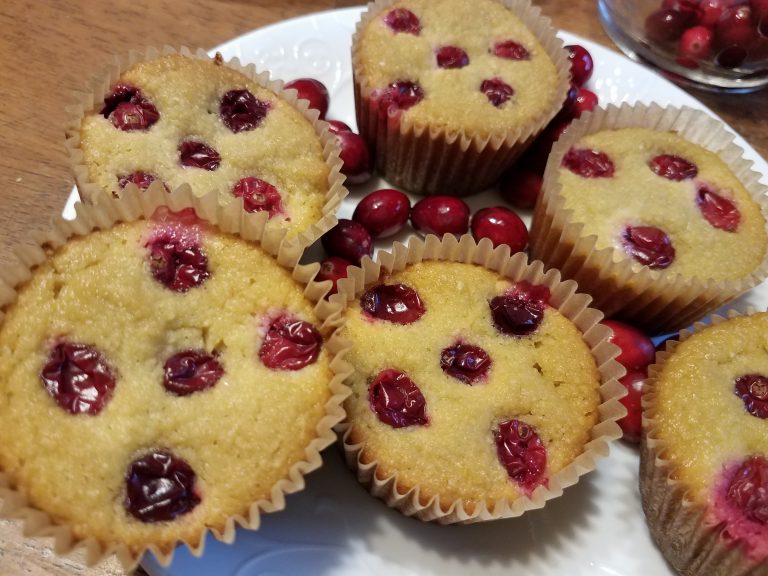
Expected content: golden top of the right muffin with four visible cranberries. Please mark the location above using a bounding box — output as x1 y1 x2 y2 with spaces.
558 128 768 280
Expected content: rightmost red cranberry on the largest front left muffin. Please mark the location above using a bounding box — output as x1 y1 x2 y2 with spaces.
259 315 323 370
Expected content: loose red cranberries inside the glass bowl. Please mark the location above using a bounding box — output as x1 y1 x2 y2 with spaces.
645 0 768 69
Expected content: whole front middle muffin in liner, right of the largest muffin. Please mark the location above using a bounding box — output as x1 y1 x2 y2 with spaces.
339 236 624 523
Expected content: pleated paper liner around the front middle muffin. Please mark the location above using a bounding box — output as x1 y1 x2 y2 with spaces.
331 234 626 524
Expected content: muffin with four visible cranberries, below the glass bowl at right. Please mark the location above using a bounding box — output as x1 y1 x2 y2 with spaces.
530 105 768 333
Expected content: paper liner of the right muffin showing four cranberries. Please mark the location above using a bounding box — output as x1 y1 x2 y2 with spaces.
530 104 768 333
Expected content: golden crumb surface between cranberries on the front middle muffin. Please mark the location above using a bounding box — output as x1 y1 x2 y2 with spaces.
344 262 600 505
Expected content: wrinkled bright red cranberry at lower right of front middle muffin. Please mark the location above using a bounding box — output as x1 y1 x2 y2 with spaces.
493 419 547 494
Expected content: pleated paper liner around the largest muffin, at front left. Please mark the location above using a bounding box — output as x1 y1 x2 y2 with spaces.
0 182 352 572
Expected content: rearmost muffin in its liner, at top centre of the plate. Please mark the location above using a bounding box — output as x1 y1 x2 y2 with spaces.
352 0 569 196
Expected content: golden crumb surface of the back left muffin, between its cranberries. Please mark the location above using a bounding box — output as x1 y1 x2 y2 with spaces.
80 55 329 236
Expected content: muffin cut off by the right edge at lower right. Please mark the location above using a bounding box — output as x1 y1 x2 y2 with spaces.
640 313 768 576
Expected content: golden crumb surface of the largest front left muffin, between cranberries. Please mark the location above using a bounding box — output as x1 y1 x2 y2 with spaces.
0 217 331 551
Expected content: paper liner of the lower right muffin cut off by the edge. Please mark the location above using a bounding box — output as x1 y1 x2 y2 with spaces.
640 309 768 576
